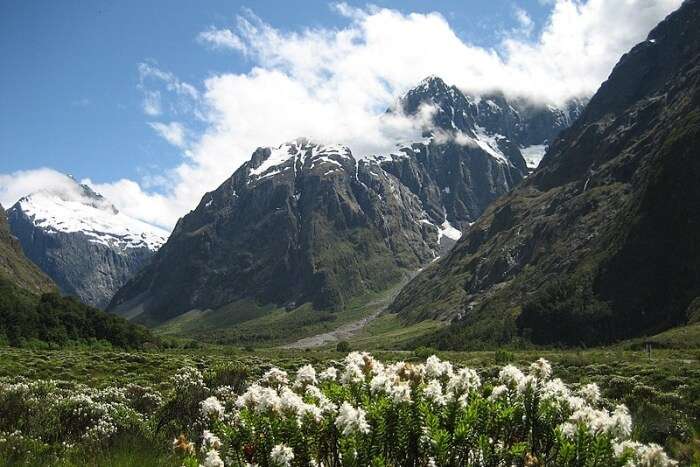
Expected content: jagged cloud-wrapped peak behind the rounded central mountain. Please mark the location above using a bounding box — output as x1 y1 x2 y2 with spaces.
374 76 583 252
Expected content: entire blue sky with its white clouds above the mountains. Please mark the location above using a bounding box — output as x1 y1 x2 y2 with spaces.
0 0 680 228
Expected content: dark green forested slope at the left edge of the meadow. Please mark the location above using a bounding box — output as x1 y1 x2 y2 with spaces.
0 279 155 349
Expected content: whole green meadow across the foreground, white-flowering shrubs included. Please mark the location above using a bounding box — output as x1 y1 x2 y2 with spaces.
0 345 700 466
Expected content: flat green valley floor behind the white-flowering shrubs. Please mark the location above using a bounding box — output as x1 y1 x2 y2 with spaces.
0 344 700 465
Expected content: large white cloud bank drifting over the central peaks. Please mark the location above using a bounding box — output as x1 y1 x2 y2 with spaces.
1 0 681 232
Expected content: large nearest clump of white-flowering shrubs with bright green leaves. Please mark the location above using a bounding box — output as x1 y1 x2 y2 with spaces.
174 352 676 467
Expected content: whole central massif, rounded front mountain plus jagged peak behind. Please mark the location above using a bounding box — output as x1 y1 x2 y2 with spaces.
109 77 580 325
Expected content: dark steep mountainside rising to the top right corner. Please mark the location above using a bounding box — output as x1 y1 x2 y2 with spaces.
391 0 700 348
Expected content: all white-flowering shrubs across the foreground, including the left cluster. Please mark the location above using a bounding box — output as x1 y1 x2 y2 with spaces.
0 352 676 467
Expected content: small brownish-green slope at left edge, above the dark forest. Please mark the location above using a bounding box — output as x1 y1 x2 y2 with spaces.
0 206 56 294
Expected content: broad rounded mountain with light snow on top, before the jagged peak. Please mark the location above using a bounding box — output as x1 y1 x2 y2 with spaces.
111 139 438 323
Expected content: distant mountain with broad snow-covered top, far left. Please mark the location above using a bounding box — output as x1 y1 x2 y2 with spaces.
8 177 167 308
